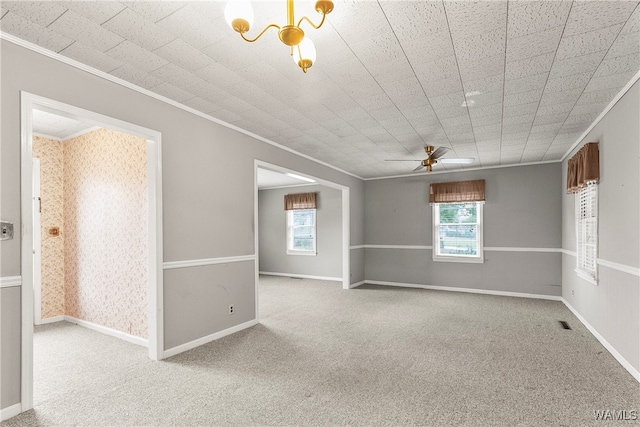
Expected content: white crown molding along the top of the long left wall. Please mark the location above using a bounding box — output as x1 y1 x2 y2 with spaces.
0 31 362 179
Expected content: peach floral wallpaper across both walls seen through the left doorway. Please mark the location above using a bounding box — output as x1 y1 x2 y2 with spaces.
33 129 148 338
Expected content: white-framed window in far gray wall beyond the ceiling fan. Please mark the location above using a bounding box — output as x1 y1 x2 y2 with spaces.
433 202 484 262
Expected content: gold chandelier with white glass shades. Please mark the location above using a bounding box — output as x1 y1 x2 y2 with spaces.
224 0 333 73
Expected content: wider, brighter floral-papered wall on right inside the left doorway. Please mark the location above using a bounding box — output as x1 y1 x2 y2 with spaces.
64 129 148 338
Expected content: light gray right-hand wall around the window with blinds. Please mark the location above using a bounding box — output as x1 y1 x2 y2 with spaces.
562 82 640 371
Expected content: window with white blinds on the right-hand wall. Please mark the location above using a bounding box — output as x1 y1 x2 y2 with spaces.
576 182 598 284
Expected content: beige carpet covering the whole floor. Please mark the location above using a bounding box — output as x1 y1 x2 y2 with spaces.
2 277 640 427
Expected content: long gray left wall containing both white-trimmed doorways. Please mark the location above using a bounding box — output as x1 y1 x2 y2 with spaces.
0 40 364 408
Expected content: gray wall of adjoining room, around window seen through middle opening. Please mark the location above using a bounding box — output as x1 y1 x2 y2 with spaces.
258 185 342 278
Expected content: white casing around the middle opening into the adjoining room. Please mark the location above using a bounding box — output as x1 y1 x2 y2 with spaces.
254 160 350 321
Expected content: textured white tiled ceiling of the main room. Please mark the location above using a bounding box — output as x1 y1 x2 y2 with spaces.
0 0 640 178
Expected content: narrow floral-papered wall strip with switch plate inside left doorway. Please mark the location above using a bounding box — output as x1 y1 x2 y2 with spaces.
33 136 65 319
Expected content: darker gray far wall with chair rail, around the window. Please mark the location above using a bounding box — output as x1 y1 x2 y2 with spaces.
365 163 562 296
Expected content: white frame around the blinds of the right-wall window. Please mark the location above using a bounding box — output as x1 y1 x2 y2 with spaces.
575 181 600 286
